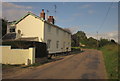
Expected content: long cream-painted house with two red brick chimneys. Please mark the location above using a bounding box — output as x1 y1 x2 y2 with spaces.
7 10 71 53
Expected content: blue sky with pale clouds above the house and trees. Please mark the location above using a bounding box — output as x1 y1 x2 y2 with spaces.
2 2 118 41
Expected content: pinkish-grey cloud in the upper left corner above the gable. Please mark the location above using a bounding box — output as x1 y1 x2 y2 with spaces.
2 2 32 21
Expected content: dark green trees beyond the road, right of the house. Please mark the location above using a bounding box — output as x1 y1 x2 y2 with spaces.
72 31 117 48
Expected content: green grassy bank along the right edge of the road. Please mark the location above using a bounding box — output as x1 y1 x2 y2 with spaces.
100 45 118 79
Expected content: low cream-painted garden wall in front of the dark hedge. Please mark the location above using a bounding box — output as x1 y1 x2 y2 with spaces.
0 46 35 65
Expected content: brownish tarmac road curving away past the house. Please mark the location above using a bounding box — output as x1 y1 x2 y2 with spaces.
3 49 107 79
